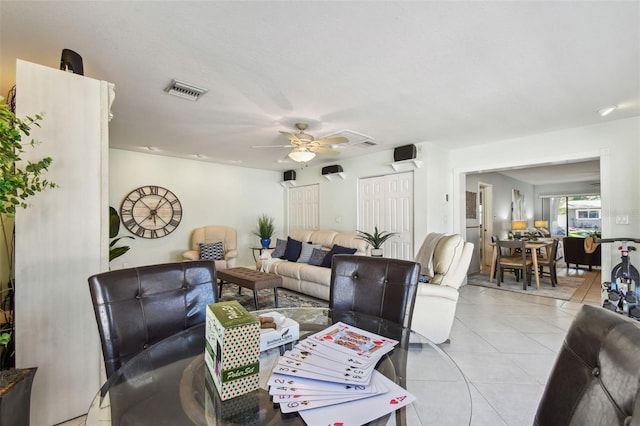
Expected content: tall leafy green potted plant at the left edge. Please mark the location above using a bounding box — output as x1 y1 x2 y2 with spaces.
0 97 56 426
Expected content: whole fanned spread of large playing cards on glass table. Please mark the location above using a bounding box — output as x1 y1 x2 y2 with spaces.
268 322 416 426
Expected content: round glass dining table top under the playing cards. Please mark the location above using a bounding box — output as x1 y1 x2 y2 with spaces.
86 308 471 426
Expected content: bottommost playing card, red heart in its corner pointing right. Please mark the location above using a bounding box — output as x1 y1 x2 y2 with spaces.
300 371 416 426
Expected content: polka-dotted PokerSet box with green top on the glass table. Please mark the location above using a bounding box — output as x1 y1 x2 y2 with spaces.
204 301 260 401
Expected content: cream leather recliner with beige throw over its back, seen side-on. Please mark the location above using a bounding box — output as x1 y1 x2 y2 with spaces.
411 233 473 343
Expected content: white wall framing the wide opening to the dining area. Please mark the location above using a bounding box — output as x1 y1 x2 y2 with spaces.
451 117 640 271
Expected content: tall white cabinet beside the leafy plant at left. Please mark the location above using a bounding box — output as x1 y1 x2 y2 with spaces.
16 60 113 426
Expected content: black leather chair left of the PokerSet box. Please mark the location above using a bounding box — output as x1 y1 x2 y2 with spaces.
89 260 217 378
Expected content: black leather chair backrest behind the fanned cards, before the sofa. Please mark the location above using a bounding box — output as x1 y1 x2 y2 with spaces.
329 255 420 327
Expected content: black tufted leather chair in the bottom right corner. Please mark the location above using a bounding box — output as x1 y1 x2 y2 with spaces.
534 305 640 426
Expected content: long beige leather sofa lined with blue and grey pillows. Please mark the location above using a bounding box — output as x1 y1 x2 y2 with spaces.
256 229 368 300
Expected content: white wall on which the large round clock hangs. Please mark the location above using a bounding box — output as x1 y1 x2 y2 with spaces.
109 150 286 269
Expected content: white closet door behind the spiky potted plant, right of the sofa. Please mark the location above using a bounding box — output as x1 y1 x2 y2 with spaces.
358 172 413 260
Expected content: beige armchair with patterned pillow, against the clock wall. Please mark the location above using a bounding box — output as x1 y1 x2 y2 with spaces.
182 226 238 270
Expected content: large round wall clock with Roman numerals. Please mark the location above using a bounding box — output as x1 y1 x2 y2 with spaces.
120 185 182 238
